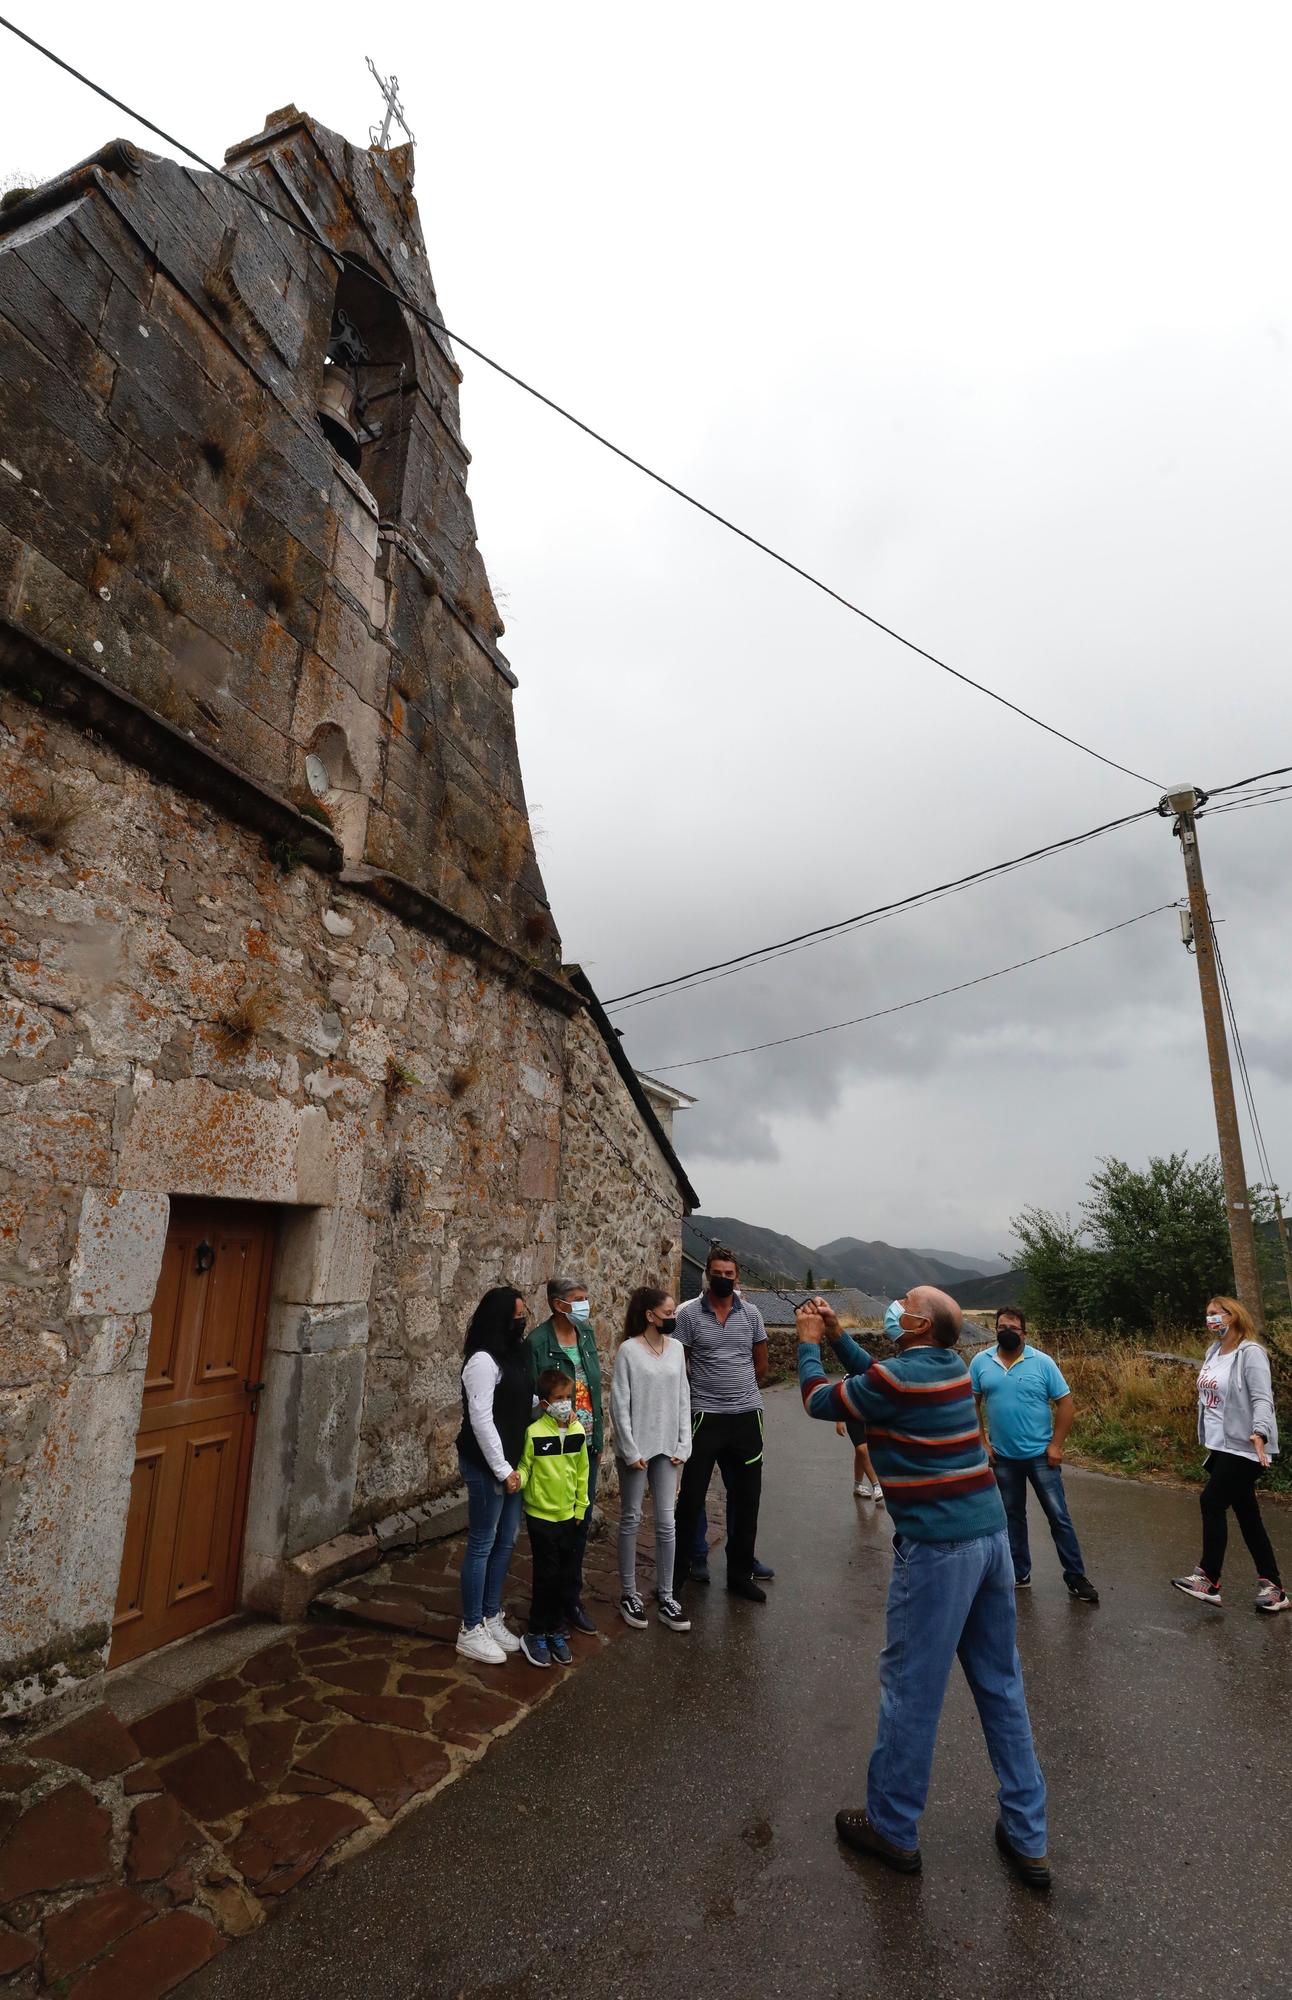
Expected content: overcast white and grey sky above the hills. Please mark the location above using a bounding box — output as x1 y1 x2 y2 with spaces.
0 0 1292 1252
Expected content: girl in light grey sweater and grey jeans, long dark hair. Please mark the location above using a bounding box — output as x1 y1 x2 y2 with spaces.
610 1284 690 1632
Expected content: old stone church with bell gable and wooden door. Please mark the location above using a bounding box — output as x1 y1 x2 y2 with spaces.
0 106 696 1716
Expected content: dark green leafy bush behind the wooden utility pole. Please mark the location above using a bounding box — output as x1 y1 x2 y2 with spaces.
1012 1152 1234 1334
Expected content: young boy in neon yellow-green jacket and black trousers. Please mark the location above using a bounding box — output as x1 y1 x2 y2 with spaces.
516 1368 588 1666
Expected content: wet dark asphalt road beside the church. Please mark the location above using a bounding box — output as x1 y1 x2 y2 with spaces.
184 1390 1292 2000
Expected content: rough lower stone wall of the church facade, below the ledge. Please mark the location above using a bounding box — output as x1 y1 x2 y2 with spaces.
0 698 564 1712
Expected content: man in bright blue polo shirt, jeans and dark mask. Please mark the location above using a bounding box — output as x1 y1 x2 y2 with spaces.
970 1306 1100 1604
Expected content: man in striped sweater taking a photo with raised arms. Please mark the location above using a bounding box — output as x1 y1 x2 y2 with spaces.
798 1286 1050 1888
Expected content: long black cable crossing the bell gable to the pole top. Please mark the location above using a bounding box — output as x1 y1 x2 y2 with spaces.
0 16 1162 790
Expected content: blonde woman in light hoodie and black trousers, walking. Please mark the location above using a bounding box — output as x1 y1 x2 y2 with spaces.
1172 1296 1292 1612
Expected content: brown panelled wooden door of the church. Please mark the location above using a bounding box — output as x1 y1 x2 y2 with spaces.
110 1202 276 1666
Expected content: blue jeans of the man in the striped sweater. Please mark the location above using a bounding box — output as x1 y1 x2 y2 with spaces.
866 1528 1046 1854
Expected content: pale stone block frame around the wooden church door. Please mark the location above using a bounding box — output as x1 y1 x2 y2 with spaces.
70 1078 376 1658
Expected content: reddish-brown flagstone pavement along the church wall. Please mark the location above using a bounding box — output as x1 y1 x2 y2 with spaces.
0 1514 700 2000
